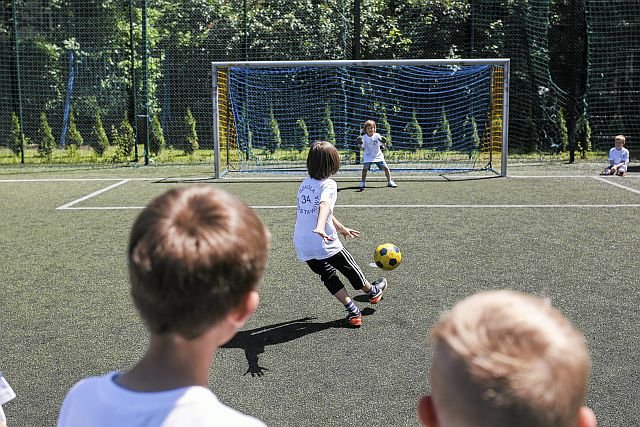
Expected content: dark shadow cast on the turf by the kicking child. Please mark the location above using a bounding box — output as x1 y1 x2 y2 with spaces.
222 307 375 377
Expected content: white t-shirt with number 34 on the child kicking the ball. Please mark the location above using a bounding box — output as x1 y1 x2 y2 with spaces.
293 177 343 261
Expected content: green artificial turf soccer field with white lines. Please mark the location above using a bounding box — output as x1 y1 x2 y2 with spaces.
0 164 640 427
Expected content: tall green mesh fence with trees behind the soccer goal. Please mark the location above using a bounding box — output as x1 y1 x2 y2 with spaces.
0 0 640 163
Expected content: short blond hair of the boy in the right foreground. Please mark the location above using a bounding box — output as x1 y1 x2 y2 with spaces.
432 291 589 427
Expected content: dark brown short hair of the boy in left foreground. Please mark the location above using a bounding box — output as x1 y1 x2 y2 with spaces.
128 186 270 339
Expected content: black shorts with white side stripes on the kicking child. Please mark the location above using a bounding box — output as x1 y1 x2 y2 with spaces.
307 248 367 295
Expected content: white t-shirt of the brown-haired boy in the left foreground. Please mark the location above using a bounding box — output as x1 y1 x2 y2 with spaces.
58 372 265 427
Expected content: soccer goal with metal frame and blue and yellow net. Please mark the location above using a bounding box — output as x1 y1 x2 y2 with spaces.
212 59 509 177
